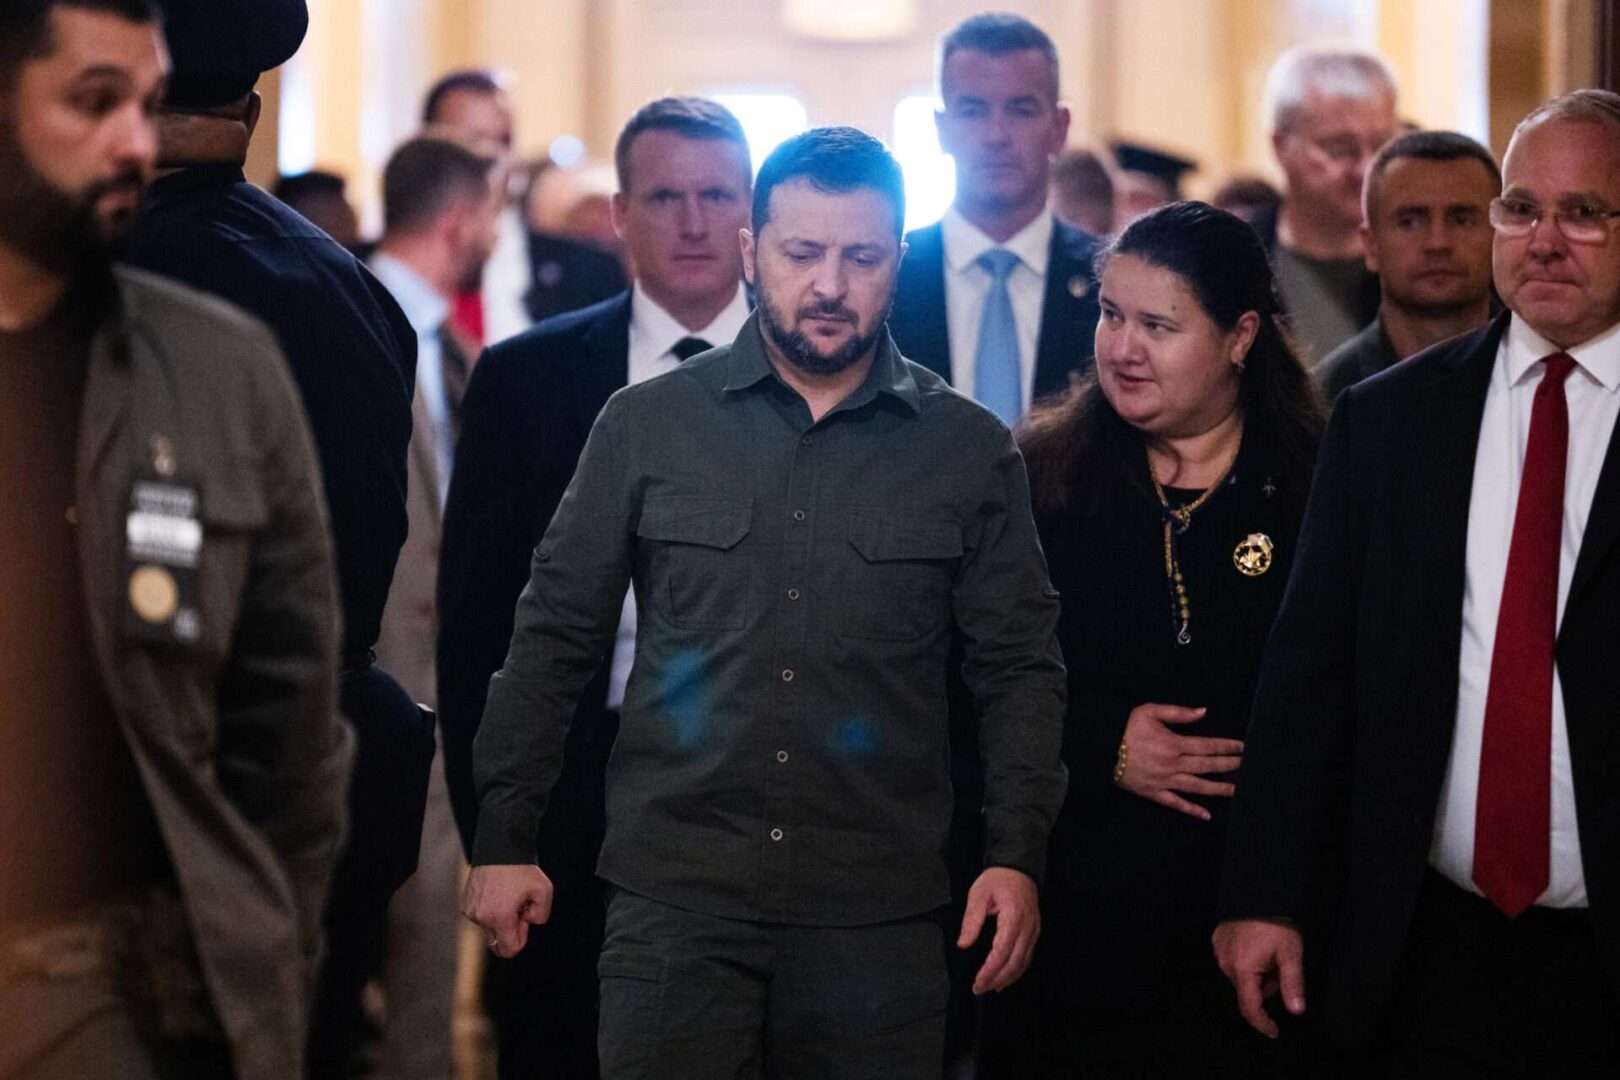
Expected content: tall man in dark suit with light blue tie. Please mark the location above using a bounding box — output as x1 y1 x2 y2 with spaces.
889 15 1097 424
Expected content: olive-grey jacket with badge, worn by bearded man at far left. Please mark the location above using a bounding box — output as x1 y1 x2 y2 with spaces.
76 269 353 1080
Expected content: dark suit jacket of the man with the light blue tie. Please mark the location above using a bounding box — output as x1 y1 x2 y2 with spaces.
889 222 1097 400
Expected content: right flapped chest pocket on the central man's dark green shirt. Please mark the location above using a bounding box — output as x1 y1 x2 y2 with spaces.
841 510 962 641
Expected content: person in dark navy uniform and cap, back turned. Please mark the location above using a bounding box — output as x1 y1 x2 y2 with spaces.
126 0 434 1075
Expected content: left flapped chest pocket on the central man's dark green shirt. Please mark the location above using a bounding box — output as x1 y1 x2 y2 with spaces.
635 495 753 630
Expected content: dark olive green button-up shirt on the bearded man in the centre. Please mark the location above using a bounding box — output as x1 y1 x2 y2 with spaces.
473 317 1064 926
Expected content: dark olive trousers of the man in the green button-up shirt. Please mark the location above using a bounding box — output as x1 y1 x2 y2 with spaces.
598 889 948 1080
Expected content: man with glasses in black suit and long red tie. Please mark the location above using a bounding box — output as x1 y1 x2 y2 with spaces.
1215 91 1620 1077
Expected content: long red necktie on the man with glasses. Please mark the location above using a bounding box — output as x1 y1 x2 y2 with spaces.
1474 353 1575 918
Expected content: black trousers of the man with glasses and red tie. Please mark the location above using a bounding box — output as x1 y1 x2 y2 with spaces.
1354 871 1620 1078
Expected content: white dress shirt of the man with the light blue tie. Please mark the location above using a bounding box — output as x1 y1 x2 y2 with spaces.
940 206 1053 410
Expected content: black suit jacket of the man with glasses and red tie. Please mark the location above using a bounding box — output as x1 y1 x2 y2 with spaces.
1221 316 1620 1046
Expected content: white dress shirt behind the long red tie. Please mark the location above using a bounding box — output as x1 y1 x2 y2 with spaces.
1429 317 1620 907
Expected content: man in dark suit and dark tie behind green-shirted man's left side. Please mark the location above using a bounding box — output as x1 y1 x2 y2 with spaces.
439 97 753 1080
